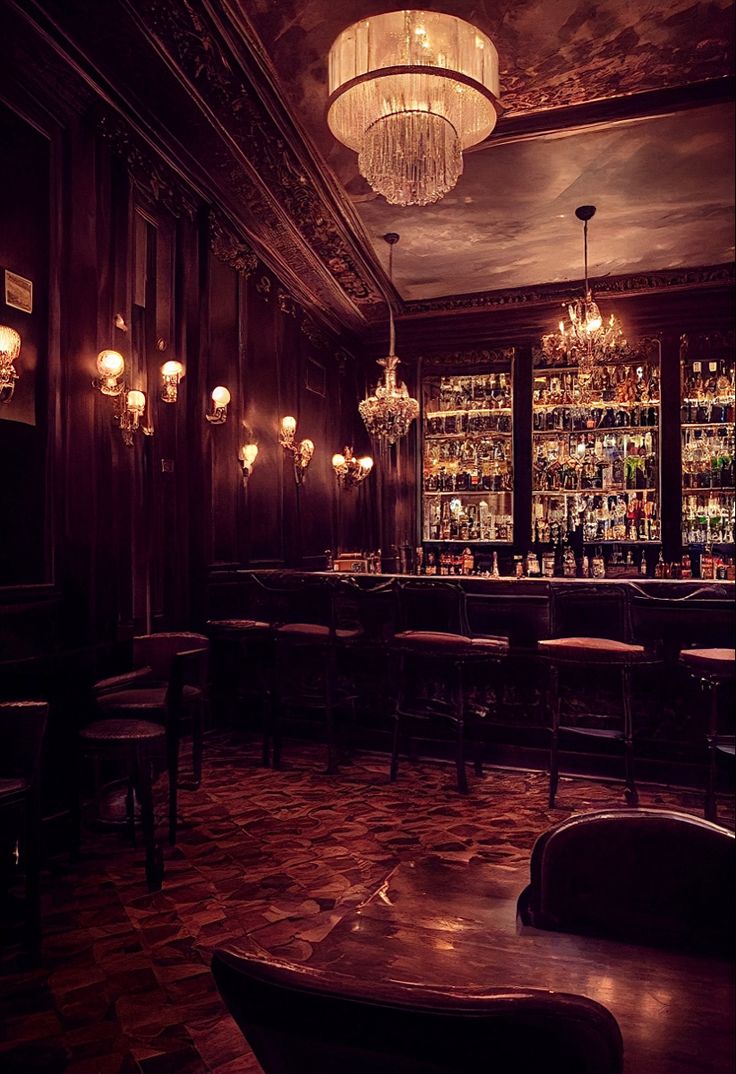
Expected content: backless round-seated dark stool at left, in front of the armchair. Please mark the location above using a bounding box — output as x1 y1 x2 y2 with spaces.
75 717 166 891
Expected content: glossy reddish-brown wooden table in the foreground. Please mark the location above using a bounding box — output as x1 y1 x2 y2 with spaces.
309 858 735 1074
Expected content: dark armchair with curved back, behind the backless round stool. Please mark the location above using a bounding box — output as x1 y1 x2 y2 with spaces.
93 633 210 846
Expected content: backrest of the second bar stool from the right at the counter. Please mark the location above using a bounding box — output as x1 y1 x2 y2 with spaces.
550 582 629 641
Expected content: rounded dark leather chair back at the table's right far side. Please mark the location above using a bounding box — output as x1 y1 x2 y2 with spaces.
519 809 735 952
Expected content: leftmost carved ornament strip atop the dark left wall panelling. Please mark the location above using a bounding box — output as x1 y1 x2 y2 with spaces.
97 108 198 220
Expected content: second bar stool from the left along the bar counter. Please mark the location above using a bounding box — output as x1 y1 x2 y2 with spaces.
269 577 360 775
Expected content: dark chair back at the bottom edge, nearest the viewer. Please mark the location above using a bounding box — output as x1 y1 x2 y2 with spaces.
212 948 622 1074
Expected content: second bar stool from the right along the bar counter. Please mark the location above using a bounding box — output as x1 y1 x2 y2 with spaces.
537 582 661 809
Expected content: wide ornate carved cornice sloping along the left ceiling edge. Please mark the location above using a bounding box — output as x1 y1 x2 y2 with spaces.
135 0 381 306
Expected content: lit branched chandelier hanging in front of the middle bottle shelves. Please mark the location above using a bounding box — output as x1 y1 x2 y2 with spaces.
542 205 630 404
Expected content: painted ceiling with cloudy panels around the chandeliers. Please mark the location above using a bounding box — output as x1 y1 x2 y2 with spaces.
239 0 734 300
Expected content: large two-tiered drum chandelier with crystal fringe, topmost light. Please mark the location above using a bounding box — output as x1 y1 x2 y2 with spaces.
327 11 499 205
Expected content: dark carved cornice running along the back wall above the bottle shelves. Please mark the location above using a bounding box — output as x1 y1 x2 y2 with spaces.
402 262 734 315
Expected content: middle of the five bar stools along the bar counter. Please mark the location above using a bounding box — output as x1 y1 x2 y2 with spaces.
390 579 508 794
